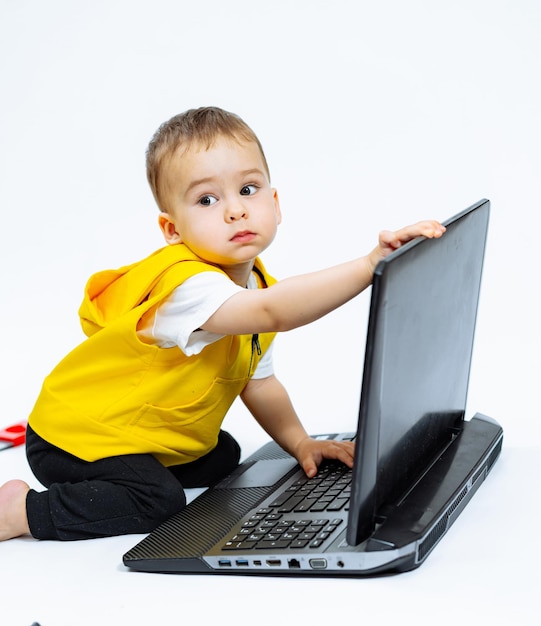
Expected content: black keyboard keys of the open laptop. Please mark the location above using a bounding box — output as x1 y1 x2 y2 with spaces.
223 462 351 550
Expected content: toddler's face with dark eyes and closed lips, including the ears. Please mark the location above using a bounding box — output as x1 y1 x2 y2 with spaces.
159 138 281 282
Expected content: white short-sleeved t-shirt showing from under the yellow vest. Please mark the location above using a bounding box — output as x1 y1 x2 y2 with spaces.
137 272 274 378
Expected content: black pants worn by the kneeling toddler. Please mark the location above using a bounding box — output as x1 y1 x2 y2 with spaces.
26 427 240 541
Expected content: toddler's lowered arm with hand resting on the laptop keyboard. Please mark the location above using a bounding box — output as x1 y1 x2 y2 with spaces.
241 376 354 477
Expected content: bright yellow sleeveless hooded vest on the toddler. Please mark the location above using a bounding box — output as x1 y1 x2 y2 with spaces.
29 244 276 465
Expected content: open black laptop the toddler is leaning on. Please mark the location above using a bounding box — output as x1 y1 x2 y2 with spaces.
123 200 503 576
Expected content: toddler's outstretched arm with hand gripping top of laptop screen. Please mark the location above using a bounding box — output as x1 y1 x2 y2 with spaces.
202 221 445 335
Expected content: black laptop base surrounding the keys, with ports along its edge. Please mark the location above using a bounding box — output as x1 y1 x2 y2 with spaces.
123 413 503 577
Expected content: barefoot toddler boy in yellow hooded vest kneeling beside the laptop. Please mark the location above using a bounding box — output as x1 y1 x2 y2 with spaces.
0 107 445 540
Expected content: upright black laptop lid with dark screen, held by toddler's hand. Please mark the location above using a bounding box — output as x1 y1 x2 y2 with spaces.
347 200 490 545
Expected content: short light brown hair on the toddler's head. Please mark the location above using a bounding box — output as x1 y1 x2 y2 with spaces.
146 107 270 212
